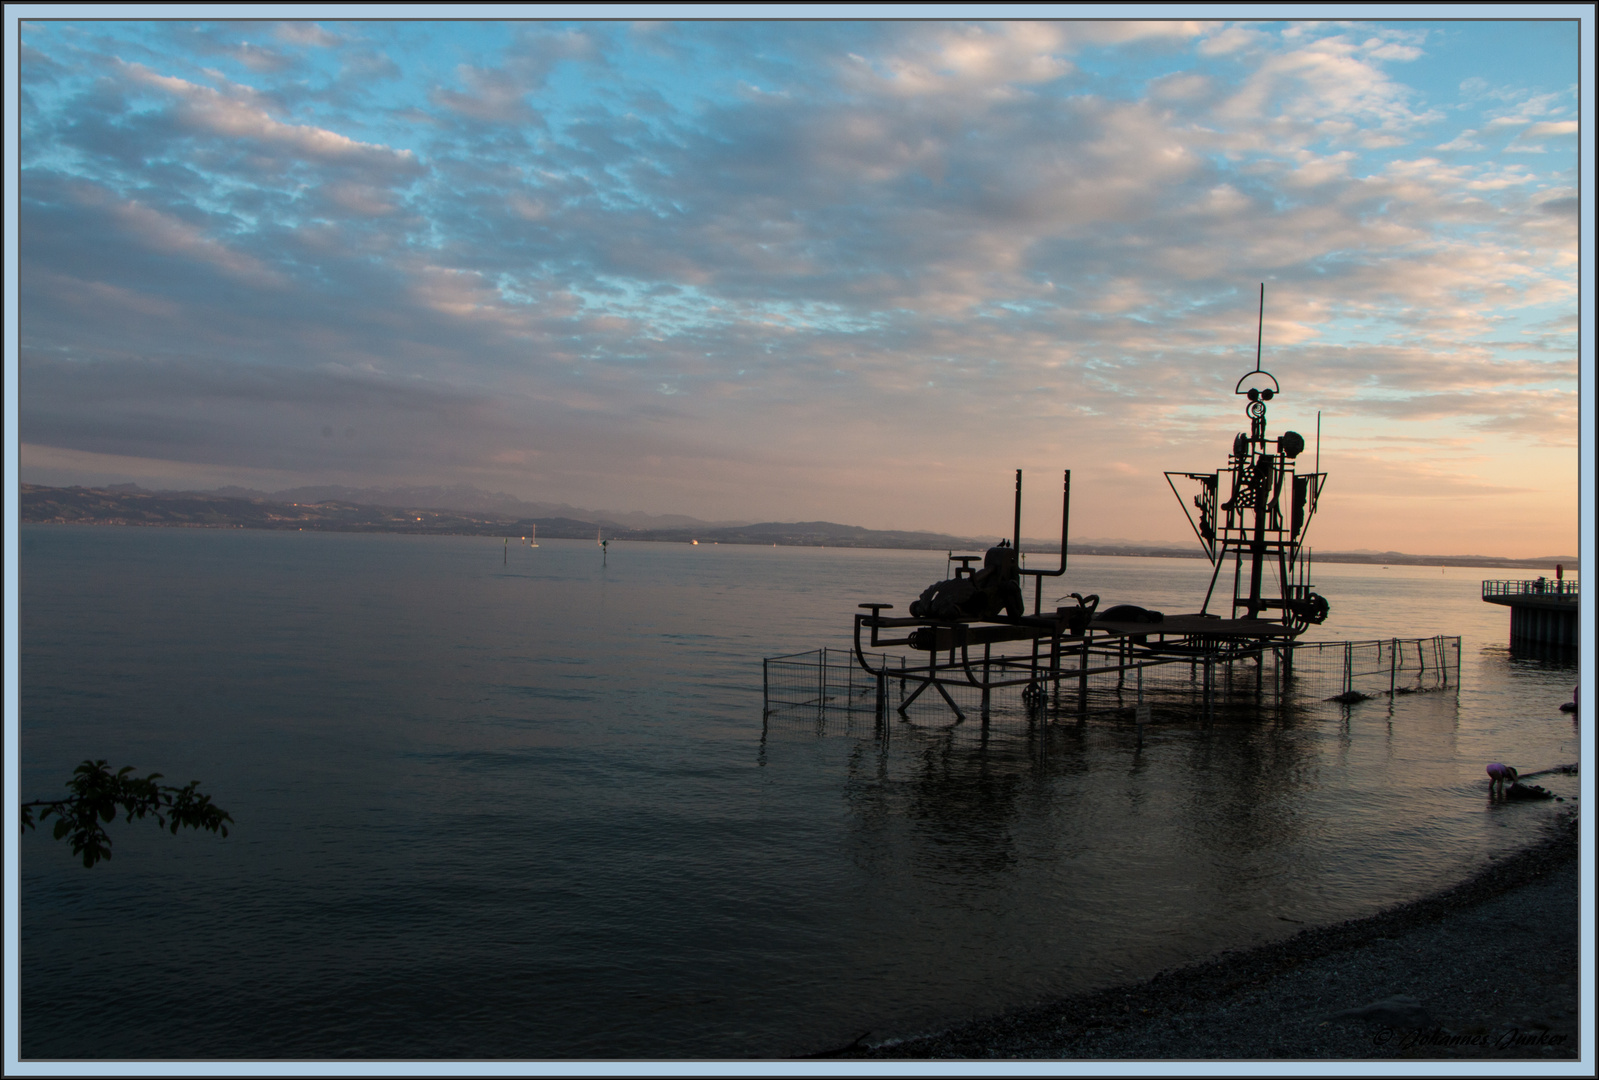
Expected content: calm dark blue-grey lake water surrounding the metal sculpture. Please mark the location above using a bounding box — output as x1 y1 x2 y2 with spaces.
12 526 1578 1058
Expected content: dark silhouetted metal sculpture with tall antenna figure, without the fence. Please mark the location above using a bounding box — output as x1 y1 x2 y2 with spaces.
819 285 1327 722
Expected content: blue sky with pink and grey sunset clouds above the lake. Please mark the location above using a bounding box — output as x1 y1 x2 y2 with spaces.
13 10 1593 557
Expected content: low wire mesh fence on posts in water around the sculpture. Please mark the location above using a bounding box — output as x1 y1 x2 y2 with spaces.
763 637 1460 736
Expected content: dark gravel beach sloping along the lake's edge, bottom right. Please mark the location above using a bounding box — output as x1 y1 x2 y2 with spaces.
815 811 1578 1061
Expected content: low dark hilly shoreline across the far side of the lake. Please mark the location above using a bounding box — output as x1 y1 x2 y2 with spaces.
21 483 1580 574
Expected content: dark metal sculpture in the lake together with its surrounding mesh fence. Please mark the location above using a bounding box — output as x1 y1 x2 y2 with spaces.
766 288 1460 725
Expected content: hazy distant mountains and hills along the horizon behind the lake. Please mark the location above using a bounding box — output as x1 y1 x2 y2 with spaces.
21 483 1578 573
